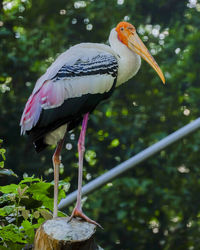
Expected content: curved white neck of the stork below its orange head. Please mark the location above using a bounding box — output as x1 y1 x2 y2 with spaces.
109 29 141 86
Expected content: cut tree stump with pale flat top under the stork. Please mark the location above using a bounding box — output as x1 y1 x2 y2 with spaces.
33 217 102 250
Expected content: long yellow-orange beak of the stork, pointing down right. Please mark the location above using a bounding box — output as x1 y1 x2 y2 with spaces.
128 33 165 83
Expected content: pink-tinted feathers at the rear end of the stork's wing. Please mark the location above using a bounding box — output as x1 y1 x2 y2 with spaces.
20 80 65 134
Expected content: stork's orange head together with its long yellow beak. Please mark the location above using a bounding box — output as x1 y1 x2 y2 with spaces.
115 22 165 83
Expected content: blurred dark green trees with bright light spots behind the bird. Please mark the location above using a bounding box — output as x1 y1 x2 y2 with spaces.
0 0 200 250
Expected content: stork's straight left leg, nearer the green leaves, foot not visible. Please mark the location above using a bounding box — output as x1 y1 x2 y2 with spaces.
53 138 64 218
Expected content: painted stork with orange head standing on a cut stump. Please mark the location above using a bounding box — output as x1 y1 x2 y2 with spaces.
20 21 165 227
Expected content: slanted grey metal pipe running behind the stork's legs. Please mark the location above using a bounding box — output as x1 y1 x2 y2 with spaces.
58 118 200 209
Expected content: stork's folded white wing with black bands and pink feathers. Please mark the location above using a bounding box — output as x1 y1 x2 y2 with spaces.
20 46 118 134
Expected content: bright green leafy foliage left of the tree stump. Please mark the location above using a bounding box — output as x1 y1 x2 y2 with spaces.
0 177 65 249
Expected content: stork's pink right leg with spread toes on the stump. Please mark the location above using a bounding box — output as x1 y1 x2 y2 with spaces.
69 113 102 228
